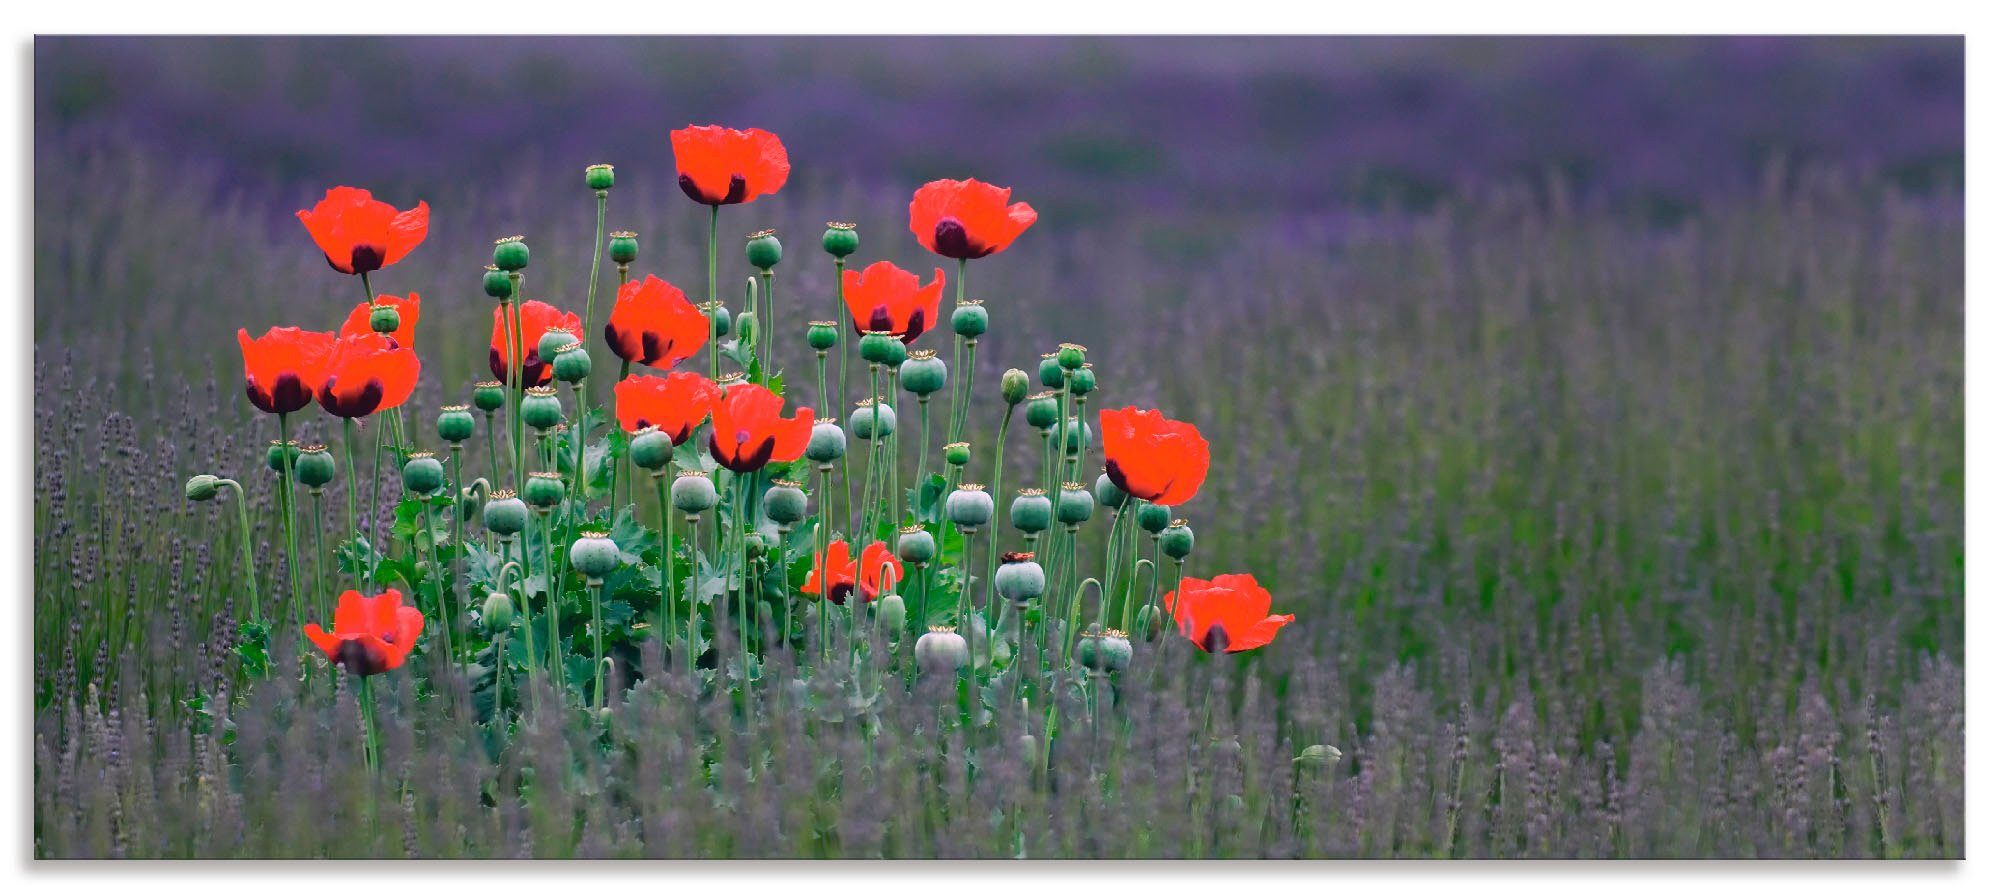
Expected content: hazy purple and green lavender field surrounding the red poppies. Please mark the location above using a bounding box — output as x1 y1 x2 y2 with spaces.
34 38 1966 858
